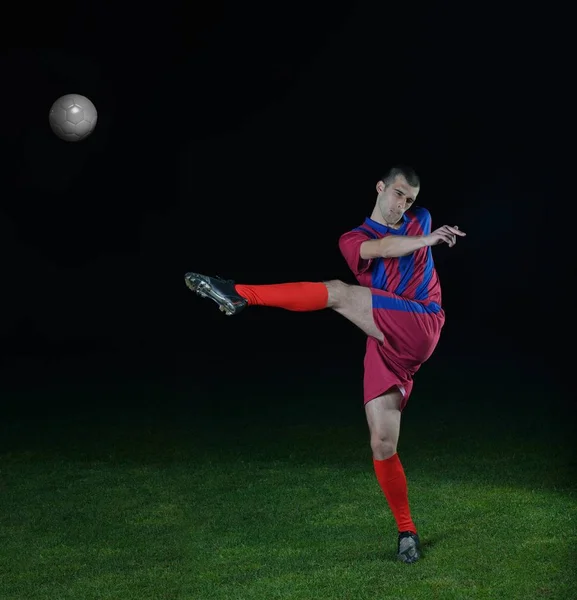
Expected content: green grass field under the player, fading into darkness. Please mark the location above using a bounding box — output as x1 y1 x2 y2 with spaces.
0 354 577 600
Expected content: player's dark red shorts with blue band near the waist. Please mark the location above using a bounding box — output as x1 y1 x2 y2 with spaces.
363 289 445 411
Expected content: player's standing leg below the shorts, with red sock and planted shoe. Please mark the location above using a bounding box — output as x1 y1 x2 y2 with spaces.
365 387 420 563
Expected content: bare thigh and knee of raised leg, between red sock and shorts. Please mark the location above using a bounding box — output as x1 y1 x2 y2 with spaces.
325 281 385 342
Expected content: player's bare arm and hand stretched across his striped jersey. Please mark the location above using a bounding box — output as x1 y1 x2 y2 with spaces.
360 225 467 260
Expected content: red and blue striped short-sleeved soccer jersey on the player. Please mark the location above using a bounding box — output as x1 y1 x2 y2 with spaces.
339 206 441 313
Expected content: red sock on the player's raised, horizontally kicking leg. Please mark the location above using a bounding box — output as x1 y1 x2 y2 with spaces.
235 282 329 312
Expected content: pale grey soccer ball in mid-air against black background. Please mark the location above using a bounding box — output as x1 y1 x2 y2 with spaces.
48 94 98 142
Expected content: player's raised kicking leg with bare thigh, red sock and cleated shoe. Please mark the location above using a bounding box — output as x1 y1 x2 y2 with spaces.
184 273 384 341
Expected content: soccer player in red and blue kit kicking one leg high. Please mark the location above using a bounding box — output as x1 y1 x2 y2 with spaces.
185 166 465 563
